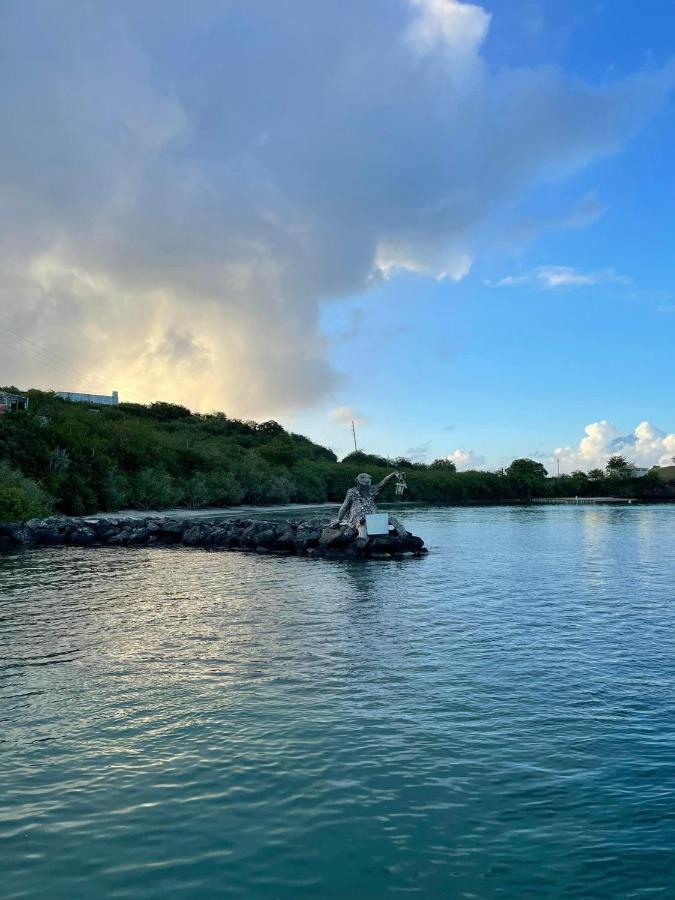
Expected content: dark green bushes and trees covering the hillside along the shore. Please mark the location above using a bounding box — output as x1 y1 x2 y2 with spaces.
0 388 658 521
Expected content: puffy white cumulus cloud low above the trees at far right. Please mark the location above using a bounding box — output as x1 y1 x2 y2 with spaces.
553 419 675 473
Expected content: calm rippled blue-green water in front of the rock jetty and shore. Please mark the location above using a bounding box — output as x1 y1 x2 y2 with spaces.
0 506 675 900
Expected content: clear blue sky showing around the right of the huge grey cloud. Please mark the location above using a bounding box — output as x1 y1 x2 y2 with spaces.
290 2 675 471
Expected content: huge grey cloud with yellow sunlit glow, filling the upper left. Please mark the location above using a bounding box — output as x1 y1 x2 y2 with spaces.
0 0 674 415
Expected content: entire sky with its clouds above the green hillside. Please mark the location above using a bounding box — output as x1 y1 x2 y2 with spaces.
0 0 675 473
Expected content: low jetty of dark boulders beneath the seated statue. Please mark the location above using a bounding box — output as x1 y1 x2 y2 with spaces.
0 516 427 559
